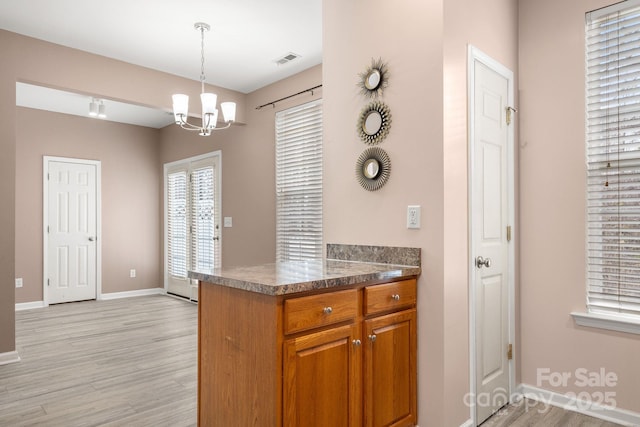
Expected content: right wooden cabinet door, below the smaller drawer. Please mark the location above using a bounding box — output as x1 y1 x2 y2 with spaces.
363 309 417 427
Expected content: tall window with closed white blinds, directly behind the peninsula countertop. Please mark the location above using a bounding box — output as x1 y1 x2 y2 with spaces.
276 100 322 261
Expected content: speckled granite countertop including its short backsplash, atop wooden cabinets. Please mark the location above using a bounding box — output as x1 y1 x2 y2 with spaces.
189 245 421 295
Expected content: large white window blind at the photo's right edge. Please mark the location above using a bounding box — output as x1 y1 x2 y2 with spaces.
586 1 640 315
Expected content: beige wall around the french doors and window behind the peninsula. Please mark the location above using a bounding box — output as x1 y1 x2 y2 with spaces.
160 66 322 267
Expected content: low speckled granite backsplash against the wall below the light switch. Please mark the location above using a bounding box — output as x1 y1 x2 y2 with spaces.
327 243 421 267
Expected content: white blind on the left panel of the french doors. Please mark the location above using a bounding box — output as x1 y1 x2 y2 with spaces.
167 170 188 278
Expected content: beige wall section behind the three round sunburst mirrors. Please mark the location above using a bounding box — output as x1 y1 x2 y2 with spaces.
323 0 442 426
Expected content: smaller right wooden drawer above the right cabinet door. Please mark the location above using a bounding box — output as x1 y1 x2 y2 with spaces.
364 279 416 315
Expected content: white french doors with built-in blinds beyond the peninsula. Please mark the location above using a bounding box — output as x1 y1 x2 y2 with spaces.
164 152 221 300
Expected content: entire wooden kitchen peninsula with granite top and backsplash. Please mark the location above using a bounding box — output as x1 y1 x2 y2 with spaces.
189 244 421 426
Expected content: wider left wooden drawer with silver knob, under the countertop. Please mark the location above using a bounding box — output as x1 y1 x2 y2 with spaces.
284 289 358 334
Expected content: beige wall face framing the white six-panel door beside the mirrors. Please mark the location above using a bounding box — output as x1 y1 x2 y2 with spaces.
443 0 518 425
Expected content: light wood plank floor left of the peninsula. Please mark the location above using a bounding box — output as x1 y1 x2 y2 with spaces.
0 296 197 427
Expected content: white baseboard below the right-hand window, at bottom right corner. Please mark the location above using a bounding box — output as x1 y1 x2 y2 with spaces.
517 384 640 427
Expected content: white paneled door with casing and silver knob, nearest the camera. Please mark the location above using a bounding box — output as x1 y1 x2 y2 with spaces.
469 48 514 425
